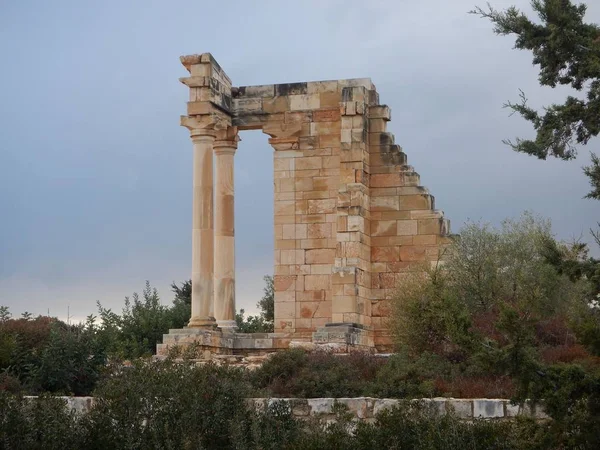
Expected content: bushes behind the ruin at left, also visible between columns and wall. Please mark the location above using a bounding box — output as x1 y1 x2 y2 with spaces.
0 276 274 395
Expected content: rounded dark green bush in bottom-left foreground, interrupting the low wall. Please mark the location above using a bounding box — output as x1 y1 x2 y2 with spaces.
82 360 249 449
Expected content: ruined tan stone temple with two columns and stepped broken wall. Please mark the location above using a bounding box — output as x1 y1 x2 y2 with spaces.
157 53 449 356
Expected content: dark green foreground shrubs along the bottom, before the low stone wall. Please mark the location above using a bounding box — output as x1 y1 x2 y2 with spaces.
0 360 568 450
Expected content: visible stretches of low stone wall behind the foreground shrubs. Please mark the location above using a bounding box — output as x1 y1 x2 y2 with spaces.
27 397 548 421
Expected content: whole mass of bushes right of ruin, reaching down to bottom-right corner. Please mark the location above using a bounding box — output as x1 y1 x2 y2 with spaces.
391 214 600 448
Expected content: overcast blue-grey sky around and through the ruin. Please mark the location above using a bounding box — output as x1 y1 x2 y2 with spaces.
0 0 600 324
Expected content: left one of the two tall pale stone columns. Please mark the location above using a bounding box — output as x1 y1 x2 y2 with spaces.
188 129 216 328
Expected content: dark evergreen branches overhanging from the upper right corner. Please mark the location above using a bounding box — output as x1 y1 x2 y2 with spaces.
471 0 600 200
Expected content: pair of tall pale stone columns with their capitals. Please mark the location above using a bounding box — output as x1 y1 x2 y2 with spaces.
188 127 239 329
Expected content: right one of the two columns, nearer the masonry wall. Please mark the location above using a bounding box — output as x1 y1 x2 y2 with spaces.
214 127 239 330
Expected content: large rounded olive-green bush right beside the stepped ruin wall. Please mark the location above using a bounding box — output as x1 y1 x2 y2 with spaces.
392 214 593 389
